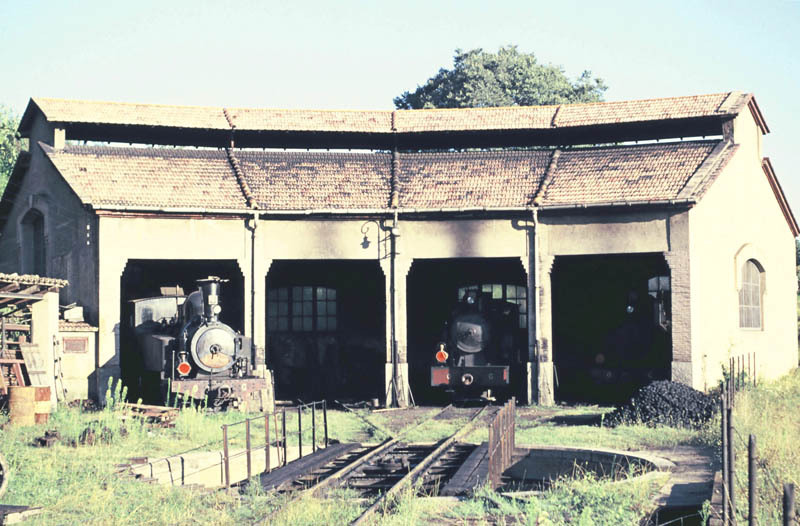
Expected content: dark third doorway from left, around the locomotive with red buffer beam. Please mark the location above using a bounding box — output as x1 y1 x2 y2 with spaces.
407 258 528 404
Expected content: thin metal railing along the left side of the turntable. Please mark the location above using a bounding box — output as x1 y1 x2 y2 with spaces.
220 400 328 487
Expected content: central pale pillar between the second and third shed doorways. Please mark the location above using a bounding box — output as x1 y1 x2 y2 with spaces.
380 257 412 407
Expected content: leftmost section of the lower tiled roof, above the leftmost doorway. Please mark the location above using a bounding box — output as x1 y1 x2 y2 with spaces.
39 143 246 209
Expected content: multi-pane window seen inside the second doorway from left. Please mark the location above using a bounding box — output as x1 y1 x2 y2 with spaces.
267 286 337 332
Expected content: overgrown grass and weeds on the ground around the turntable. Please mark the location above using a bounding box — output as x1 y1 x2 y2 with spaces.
0 371 800 526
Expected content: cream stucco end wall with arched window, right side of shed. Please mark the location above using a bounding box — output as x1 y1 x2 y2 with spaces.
689 113 797 389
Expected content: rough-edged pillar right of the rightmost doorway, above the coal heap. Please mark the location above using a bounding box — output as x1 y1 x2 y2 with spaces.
664 250 693 386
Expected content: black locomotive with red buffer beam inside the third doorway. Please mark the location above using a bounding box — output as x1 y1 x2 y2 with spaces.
431 290 520 396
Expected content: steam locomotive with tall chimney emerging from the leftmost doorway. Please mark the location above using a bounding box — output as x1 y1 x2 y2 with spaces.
126 276 267 408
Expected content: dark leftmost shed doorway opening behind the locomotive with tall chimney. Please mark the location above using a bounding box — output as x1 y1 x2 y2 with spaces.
119 259 244 403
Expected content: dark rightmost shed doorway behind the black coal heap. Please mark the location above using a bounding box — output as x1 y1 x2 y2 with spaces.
551 254 672 404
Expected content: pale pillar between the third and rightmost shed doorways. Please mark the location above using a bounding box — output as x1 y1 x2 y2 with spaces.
536 254 555 405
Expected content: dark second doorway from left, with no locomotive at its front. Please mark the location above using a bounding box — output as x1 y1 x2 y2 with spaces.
266 260 386 401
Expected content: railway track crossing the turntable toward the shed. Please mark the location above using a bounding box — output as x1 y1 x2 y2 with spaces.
265 405 495 525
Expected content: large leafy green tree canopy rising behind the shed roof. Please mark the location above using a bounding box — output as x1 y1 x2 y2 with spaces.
394 46 607 109
